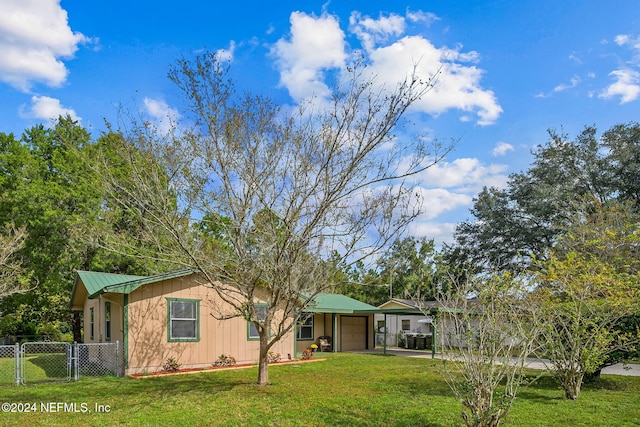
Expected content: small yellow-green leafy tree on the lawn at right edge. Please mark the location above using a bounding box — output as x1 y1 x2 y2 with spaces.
534 202 640 400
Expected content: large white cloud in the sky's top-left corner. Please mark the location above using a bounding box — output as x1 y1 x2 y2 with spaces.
0 0 90 92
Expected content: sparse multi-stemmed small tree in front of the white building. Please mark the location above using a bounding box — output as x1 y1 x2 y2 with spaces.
430 274 537 427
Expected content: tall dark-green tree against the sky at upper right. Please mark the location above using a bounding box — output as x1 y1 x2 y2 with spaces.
455 123 640 271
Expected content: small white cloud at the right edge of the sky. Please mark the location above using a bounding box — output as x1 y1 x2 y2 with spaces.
598 34 640 104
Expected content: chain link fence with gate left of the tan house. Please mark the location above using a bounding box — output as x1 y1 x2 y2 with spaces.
0 341 124 387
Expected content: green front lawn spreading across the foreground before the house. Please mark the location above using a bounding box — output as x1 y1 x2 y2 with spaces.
0 353 640 426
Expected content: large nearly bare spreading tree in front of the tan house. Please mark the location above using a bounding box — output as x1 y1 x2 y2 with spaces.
100 54 449 385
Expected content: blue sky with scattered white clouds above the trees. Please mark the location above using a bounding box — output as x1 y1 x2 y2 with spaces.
0 0 640 242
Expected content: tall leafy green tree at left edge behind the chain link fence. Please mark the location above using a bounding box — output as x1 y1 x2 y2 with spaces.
0 118 96 342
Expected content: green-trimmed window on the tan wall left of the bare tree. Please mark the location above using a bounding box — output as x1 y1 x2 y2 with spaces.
167 298 200 341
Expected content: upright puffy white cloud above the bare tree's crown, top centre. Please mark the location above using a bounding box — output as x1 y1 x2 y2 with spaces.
271 12 347 101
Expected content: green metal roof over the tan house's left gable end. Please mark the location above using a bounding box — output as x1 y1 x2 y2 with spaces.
74 269 193 298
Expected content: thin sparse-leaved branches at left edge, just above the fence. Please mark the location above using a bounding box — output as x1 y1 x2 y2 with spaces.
0 225 30 299
